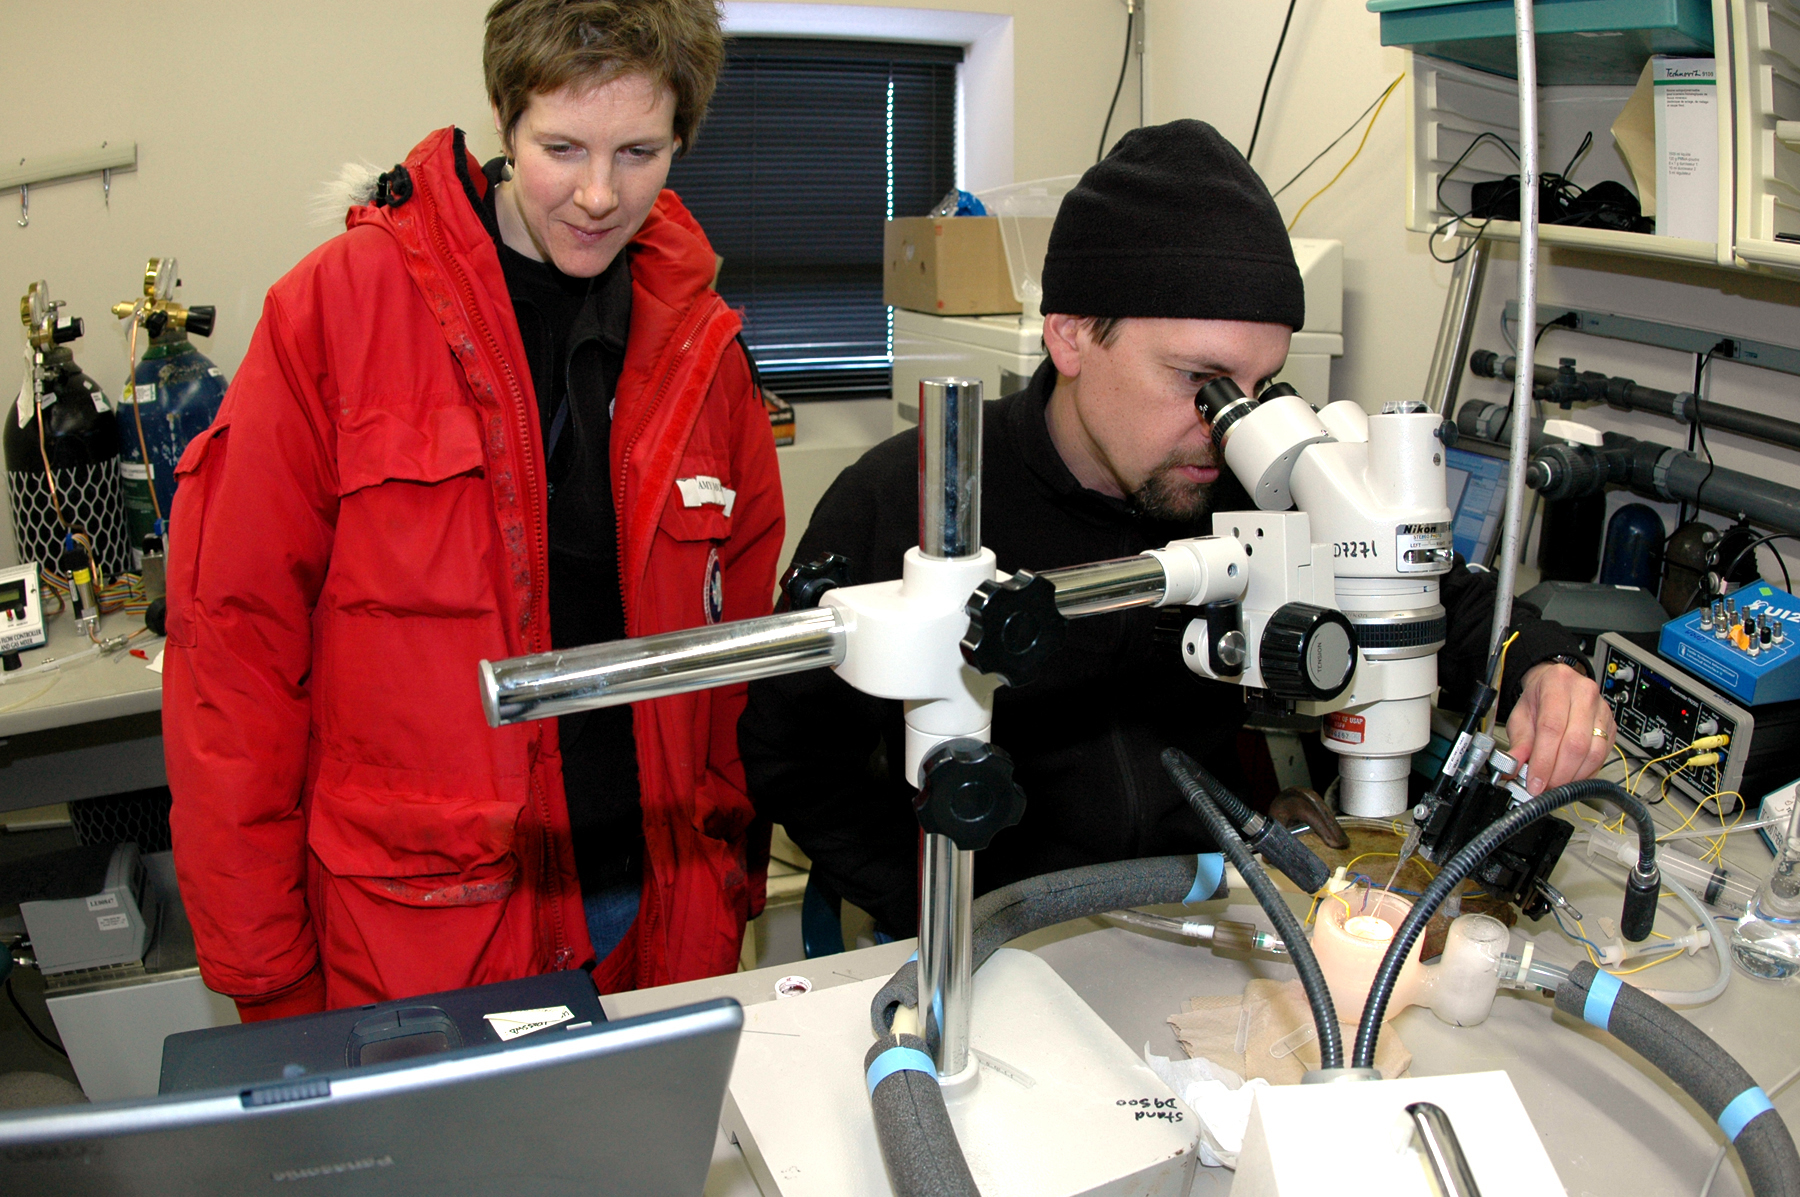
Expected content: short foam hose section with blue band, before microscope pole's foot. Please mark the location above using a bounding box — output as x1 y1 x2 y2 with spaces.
862 1035 981 1197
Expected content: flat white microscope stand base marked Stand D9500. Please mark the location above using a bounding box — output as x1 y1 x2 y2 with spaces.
722 949 1199 1197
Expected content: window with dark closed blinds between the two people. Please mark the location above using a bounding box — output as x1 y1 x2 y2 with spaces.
670 38 963 400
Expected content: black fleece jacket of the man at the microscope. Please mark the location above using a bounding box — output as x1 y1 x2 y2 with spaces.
738 362 1577 934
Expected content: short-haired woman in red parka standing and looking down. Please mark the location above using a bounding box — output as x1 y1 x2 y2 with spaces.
164 0 783 1019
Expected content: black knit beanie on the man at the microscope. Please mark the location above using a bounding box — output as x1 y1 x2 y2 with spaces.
1040 121 1307 331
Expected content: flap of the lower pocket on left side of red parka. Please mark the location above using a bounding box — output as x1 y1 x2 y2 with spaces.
306 778 520 880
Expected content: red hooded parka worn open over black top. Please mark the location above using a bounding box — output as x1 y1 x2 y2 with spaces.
162 130 783 1019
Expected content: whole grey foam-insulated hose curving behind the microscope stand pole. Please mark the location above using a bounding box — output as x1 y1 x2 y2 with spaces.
864 853 1226 1197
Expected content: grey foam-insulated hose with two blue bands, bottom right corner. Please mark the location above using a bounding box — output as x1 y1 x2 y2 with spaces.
1557 961 1800 1197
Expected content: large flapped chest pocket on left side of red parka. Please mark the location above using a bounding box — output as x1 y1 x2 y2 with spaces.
328 407 495 616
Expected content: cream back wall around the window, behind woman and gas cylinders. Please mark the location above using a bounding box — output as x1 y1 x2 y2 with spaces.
0 0 1136 385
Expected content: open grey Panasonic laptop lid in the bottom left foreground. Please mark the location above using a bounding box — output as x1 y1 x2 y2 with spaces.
0 999 743 1197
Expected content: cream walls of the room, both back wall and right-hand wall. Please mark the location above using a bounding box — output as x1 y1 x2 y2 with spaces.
0 0 1800 583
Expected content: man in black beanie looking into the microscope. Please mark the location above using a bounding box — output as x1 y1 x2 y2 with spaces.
738 121 1613 936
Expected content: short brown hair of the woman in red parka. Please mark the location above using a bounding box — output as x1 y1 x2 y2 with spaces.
481 0 725 153
